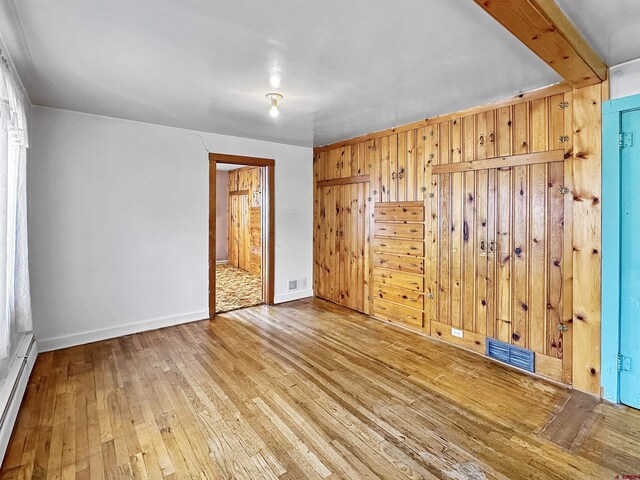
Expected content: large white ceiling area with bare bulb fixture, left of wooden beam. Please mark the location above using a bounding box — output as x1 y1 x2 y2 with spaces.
0 0 616 146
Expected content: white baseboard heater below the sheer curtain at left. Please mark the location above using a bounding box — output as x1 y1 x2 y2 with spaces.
0 333 38 463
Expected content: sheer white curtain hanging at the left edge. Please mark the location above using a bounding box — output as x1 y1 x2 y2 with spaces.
0 60 32 379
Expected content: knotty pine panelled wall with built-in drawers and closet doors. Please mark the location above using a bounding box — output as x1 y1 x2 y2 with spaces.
314 85 601 395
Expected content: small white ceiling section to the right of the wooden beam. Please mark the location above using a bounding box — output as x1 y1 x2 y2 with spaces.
556 0 640 66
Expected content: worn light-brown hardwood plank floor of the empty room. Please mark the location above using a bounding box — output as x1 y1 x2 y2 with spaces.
0 299 640 480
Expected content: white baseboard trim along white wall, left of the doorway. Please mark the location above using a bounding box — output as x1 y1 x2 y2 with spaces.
38 310 209 352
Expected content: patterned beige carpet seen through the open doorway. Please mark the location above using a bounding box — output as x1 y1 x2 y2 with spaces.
216 265 262 313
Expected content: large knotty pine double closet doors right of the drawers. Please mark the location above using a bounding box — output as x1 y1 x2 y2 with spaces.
427 161 569 360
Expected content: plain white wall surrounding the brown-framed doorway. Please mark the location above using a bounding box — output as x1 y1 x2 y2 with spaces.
28 107 313 349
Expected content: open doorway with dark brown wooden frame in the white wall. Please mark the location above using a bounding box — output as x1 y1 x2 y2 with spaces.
209 153 275 318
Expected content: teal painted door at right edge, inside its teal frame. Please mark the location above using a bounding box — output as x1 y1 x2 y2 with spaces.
619 110 640 408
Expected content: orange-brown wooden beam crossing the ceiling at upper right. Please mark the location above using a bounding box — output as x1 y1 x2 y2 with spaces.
474 0 607 88
